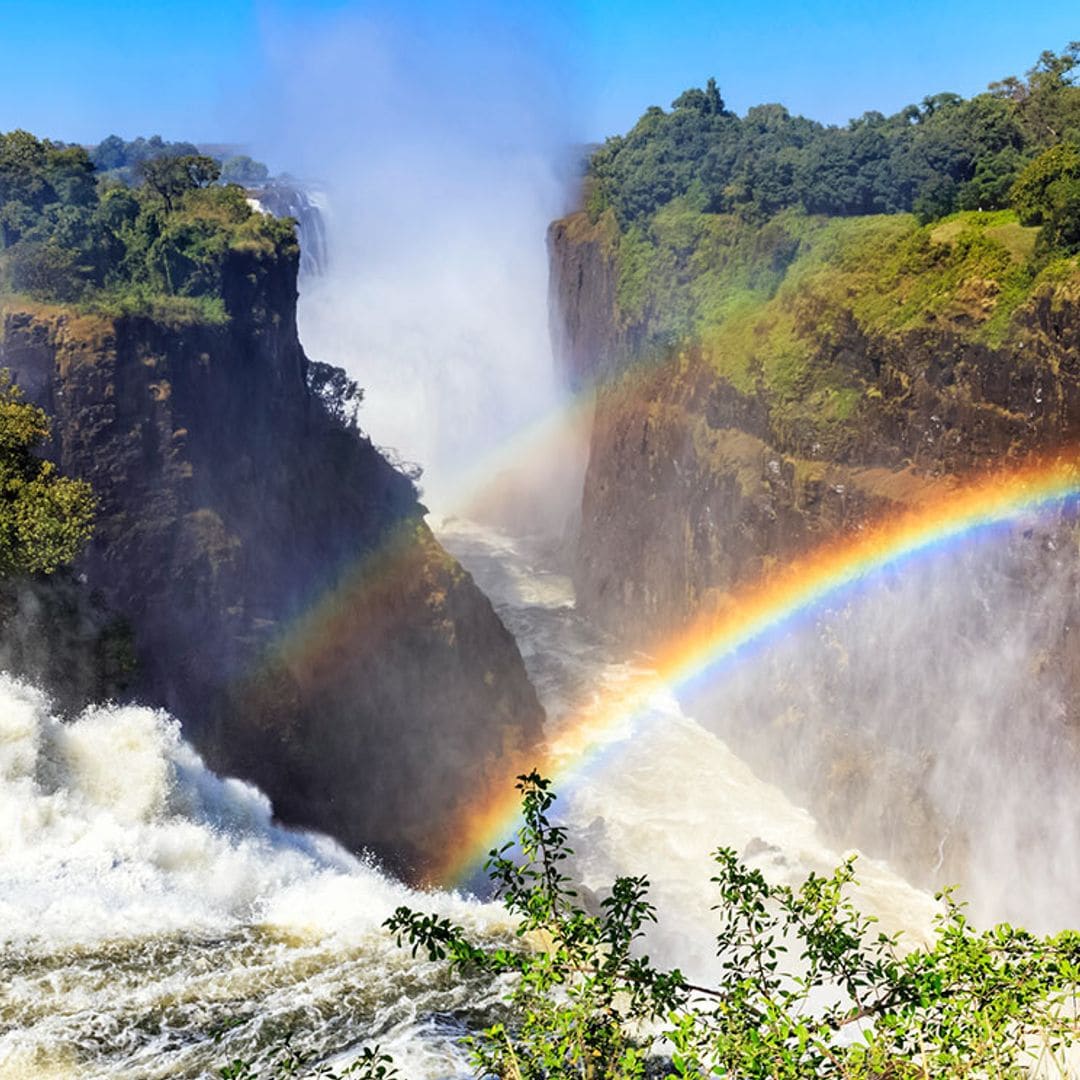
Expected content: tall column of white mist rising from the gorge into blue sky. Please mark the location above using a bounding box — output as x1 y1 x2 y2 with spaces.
247 4 576 522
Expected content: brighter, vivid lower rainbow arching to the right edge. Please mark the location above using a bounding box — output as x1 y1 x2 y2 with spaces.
434 453 1080 885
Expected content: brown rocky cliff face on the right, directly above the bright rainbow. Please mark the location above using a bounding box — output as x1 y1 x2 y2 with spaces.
549 215 1080 644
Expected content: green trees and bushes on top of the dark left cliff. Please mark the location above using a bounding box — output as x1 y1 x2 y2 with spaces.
0 131 296 322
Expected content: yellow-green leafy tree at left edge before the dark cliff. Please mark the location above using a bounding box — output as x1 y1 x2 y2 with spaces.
0 370 94 578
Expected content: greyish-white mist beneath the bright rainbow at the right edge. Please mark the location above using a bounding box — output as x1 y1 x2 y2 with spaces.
684 519 1080 932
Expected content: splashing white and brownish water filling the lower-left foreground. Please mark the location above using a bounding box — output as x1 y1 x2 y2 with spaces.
0 676 508 1080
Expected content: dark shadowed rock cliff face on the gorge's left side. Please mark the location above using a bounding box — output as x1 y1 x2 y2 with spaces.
0 236 541 875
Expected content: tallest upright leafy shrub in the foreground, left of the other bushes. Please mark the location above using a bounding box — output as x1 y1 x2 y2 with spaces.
386 772 689 1080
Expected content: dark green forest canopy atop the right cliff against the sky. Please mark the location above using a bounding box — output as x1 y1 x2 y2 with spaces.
586 42 1080 249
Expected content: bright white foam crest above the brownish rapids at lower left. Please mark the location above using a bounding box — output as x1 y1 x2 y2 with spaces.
0 675 496 948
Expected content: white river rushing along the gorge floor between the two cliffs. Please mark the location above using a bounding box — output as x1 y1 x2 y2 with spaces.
438 522 936 981
